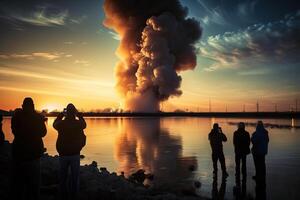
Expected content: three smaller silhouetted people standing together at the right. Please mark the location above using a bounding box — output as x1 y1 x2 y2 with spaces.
208 121 269 199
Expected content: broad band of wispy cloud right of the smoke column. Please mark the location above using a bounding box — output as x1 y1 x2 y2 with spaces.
199 12 300 73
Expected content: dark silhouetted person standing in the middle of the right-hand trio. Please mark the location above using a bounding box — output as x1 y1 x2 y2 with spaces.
233 122 250 178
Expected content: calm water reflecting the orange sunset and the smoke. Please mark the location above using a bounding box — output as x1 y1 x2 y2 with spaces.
3 117 300 199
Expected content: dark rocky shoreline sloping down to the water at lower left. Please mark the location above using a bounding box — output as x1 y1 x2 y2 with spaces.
0 142 206 200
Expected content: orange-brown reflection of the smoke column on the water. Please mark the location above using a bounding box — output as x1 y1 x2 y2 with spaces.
115 118 197 191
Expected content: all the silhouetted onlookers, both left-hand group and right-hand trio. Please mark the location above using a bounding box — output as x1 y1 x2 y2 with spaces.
0 97 269 200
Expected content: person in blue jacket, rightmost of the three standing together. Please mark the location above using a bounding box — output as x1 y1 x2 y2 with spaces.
251 121 269 181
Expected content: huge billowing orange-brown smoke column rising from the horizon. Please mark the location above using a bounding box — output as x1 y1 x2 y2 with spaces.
104 0 202 112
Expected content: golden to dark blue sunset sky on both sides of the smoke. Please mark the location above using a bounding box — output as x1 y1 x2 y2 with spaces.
0 0 300 111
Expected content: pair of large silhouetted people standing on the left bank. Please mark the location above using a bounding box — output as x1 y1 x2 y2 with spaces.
8 97 86 200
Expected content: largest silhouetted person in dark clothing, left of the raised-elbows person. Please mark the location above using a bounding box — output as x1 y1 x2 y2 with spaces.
11 97 47 200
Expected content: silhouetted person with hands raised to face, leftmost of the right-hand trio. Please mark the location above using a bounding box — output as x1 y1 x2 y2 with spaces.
208 123 228 177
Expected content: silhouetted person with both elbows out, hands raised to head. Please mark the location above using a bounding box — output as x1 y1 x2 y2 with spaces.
53 104 86 200
